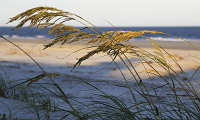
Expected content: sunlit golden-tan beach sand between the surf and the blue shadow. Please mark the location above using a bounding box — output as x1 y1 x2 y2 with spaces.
0 39 200 78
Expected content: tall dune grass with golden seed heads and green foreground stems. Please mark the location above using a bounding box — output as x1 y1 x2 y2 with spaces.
0 7 200 120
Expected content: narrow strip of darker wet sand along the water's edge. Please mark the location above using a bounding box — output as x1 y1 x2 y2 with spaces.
0 38 200 50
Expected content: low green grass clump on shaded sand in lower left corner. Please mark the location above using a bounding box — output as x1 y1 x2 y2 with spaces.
0 62 62 120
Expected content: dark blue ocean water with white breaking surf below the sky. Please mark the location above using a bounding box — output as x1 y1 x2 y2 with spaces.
0 27 200 41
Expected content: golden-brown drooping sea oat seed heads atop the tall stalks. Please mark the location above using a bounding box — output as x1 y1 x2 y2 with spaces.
8 7 194 71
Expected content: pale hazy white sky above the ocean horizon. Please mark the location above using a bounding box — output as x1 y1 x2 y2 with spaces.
0 0 200 26
